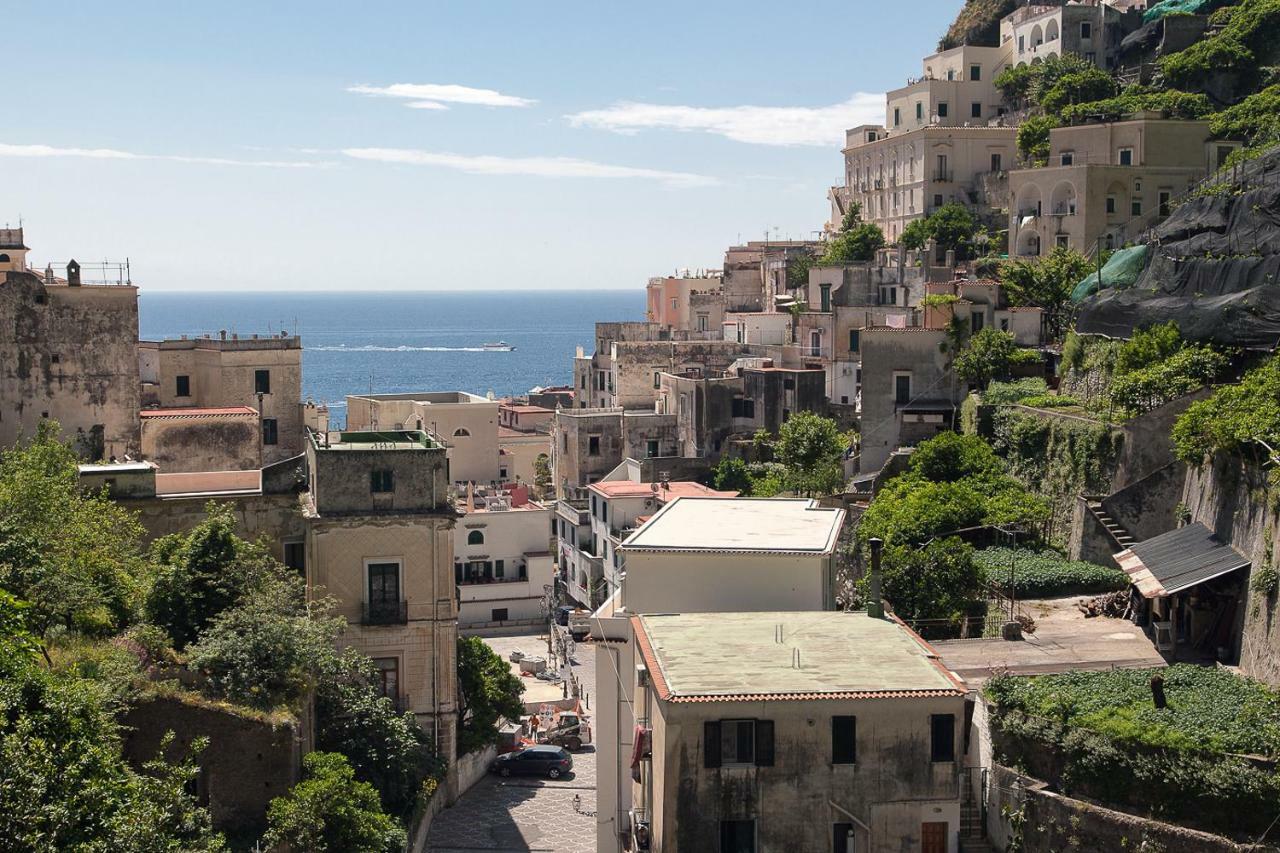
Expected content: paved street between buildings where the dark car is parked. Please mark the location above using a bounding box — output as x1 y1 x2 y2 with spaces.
426 627 595 853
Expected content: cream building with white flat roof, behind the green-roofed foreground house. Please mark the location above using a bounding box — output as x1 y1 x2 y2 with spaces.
591 497 845 853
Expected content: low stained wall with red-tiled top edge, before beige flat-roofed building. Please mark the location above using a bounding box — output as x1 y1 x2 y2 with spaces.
141 412 259 474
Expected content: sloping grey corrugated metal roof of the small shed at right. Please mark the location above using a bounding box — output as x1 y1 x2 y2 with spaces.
1115 521 1249 598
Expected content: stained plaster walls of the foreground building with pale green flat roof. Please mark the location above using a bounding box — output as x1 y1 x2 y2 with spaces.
645 691 964 853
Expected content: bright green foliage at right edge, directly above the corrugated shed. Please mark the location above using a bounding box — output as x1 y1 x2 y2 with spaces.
1174 359 1280 465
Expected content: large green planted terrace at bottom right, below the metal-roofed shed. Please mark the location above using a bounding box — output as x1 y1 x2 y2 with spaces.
984 663 1280 756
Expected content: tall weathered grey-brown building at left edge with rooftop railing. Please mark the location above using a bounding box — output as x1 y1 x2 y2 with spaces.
0 228 138 460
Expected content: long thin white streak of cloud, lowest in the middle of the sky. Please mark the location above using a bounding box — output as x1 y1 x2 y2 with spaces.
343 149 718 187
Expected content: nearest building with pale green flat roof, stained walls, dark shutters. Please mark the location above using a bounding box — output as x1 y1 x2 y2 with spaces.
624 611 968 853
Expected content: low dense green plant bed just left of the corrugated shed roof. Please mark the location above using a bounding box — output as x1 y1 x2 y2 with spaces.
974 548 1129 598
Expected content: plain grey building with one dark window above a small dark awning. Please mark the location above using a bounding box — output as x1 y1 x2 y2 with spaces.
858 325 968 473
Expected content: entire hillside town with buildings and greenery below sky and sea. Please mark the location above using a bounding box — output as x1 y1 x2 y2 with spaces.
0 0 1280 853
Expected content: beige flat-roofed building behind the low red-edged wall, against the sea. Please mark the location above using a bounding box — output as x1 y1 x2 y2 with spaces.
137 332 306 471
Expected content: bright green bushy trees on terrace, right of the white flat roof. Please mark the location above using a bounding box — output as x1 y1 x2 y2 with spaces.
858 433 1050 544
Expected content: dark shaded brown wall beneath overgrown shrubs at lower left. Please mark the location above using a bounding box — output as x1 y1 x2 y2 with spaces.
122 695 302 835
